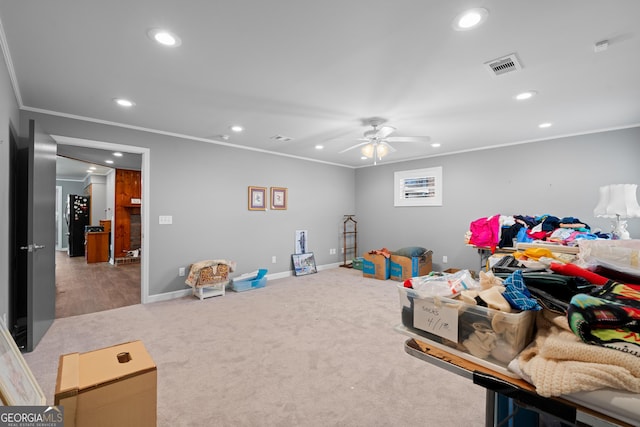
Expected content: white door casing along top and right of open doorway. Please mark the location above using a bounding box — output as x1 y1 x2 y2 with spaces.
51 135 151 304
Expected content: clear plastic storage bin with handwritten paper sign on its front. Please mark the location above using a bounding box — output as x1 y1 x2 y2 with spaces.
398 284 536 375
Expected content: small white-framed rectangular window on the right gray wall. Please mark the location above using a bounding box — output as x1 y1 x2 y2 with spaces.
394 166 442 206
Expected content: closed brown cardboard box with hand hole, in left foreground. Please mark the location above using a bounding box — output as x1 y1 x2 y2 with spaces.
55 341 157 427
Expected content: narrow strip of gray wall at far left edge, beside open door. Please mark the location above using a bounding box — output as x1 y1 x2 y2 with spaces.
0 45 19 320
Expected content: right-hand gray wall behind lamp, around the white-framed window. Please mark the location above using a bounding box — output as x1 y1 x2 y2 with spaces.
355 128 640 270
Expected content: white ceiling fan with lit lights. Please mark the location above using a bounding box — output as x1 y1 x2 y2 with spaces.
339 117 431 165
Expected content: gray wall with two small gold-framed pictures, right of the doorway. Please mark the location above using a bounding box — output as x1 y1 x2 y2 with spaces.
20 111 355 295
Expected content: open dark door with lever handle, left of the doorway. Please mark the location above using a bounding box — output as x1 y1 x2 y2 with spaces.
12 120 56 351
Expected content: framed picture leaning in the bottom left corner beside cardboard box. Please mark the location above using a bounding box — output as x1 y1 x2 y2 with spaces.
0 320 46 406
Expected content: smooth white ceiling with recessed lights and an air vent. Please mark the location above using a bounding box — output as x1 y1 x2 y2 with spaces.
0 0 640 167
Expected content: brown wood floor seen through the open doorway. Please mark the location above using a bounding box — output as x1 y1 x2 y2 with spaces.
56 251 140 318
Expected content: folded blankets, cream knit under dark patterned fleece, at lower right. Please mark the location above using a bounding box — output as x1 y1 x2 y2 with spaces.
509 263 640 397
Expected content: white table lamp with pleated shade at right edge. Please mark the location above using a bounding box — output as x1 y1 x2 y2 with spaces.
593 184 640 240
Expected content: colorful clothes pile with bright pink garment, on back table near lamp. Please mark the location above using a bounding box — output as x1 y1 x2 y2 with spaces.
465 214 611 248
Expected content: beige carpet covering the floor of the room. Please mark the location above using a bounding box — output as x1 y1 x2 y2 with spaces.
25 268 485 427
